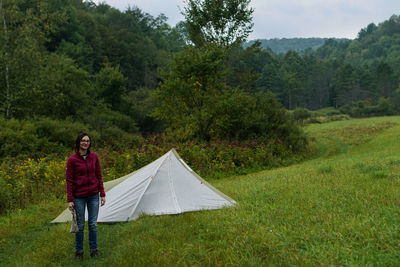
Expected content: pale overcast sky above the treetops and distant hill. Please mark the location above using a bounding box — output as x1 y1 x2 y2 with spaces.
94 0 400 40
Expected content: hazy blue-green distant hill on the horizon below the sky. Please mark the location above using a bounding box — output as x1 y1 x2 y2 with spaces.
245 38 349 54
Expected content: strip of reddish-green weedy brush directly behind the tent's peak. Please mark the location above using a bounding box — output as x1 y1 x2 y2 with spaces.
99 132 308 183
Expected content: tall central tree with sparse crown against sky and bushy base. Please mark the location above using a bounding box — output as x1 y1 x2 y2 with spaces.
153 0 305 148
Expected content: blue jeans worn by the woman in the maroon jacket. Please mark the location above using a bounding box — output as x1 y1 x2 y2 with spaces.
74 194 99 251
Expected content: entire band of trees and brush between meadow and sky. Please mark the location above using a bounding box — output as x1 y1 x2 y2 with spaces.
0 0 400 212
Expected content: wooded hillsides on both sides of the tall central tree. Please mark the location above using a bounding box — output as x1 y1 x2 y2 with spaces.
0 0 400 138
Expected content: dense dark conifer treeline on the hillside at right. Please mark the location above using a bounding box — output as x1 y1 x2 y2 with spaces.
248 15 400 115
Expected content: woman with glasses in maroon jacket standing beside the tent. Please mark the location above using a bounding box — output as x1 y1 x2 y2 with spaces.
66 133 106 259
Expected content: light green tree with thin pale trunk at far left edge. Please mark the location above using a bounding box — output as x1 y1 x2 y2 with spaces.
0 1 47 118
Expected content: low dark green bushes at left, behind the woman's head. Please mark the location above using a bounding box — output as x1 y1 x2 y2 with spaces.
0 117 143 161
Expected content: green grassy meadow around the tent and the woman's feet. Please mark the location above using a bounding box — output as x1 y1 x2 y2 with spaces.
0 117 400 266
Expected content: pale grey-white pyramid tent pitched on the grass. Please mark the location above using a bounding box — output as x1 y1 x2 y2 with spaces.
52 149 236 223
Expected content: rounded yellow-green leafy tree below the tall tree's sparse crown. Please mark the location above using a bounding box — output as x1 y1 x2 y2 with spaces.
153 44 228 140
